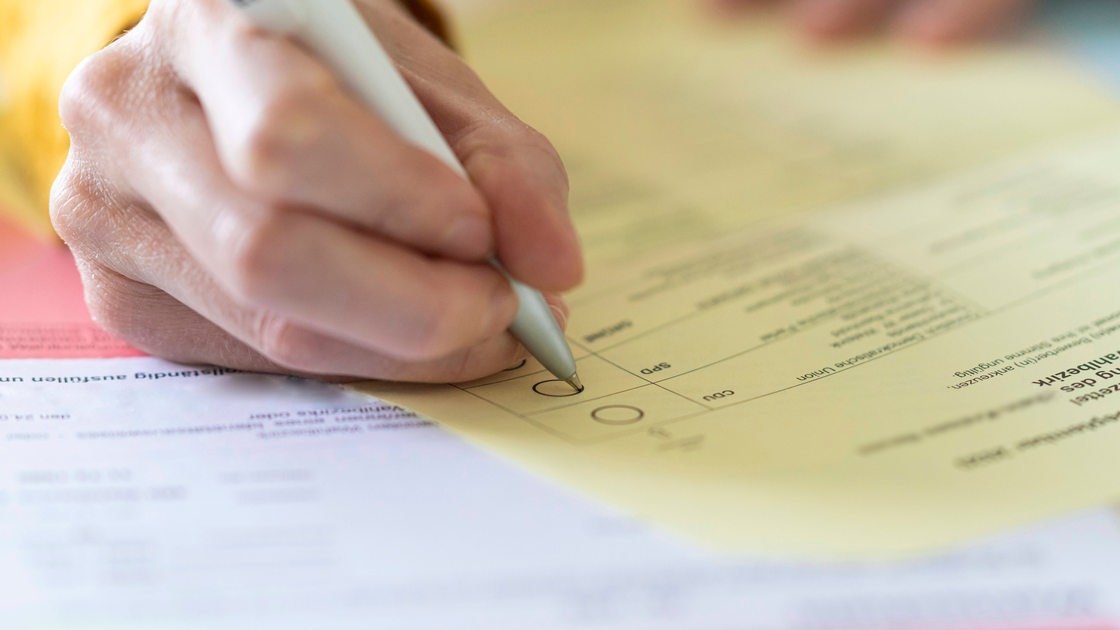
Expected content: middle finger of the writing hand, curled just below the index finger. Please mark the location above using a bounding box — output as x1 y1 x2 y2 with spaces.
123 94 516 361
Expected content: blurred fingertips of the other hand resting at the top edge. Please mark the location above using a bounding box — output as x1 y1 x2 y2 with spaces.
709 0 1029 45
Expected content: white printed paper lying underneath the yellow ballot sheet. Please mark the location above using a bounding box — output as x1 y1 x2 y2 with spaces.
0 359 1120 630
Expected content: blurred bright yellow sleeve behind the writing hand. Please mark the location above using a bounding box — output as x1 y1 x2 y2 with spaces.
0 0 148 233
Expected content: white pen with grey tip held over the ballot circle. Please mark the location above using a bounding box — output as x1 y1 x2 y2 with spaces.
222 0 584 391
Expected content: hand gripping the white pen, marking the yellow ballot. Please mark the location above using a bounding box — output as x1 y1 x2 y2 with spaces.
52 0 581 381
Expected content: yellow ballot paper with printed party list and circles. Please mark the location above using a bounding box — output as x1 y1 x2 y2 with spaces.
351 0 1120 558
